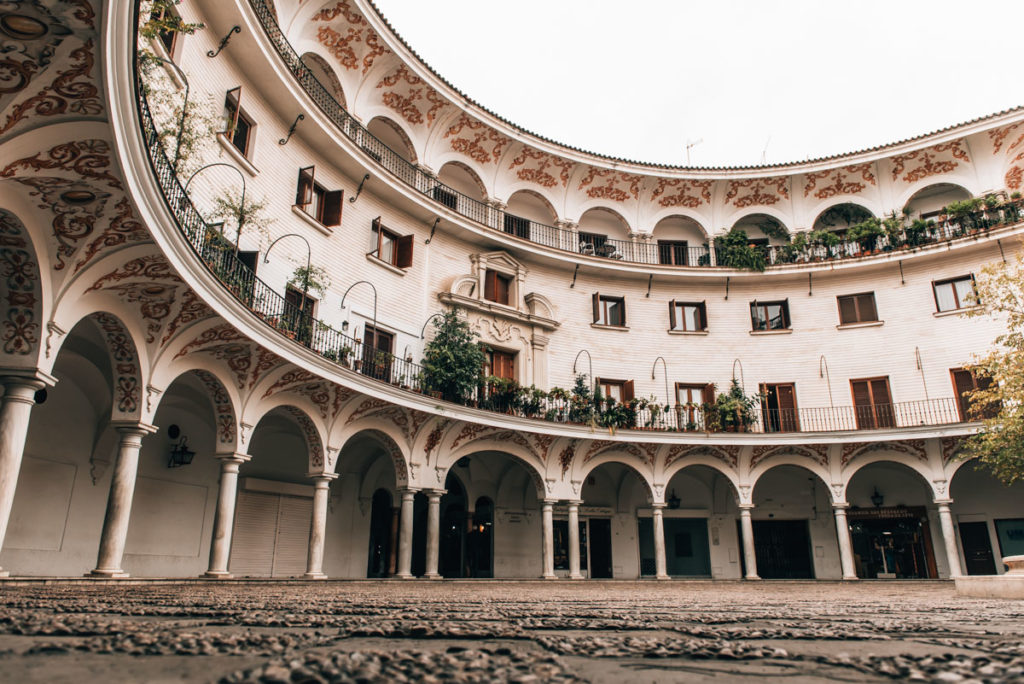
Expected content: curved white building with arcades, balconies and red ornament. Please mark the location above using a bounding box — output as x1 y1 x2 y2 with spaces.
0 0 1024 580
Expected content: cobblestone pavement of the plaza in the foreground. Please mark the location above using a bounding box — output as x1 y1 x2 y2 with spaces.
0 581 1024 684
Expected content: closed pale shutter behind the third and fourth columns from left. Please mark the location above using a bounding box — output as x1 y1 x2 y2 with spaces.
228 489 312 576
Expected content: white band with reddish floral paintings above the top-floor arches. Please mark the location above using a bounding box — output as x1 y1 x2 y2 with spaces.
299 0 1024 231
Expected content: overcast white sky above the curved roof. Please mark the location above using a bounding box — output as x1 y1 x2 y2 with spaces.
375 0 1024 166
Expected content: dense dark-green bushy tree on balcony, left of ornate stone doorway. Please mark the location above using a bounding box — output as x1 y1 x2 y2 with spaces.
422 307 486 403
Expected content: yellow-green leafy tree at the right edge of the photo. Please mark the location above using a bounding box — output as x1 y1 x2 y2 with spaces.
962 252 1024 485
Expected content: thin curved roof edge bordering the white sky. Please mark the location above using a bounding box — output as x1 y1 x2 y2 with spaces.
354 0 1024 172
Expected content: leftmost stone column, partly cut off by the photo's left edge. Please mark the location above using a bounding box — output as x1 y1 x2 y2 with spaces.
0 376 52 578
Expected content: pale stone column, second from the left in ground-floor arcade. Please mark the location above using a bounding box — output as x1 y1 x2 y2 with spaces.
89 422 157 578
